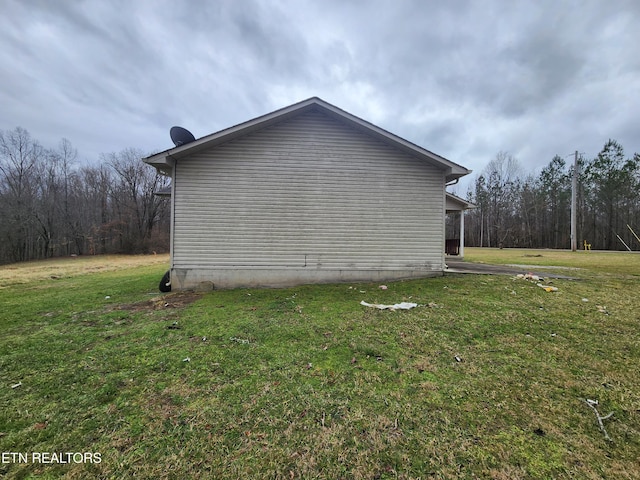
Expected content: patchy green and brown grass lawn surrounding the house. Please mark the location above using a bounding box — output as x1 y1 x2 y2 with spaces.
0 249 640 479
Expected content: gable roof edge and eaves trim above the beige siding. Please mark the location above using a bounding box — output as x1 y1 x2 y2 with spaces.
143 97 471 182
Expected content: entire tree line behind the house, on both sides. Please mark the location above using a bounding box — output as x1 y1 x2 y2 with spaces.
0 127 640 264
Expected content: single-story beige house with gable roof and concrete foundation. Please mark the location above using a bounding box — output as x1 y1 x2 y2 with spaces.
144 97 470 290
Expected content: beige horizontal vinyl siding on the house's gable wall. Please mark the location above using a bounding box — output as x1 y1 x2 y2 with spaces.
173 112 444 270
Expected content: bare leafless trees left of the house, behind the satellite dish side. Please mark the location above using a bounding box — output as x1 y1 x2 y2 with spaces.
0 127 170 263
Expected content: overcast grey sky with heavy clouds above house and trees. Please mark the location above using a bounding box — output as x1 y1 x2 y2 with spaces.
0 0 640 193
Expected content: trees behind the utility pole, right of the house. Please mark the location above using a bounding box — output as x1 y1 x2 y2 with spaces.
465 140 640 250
